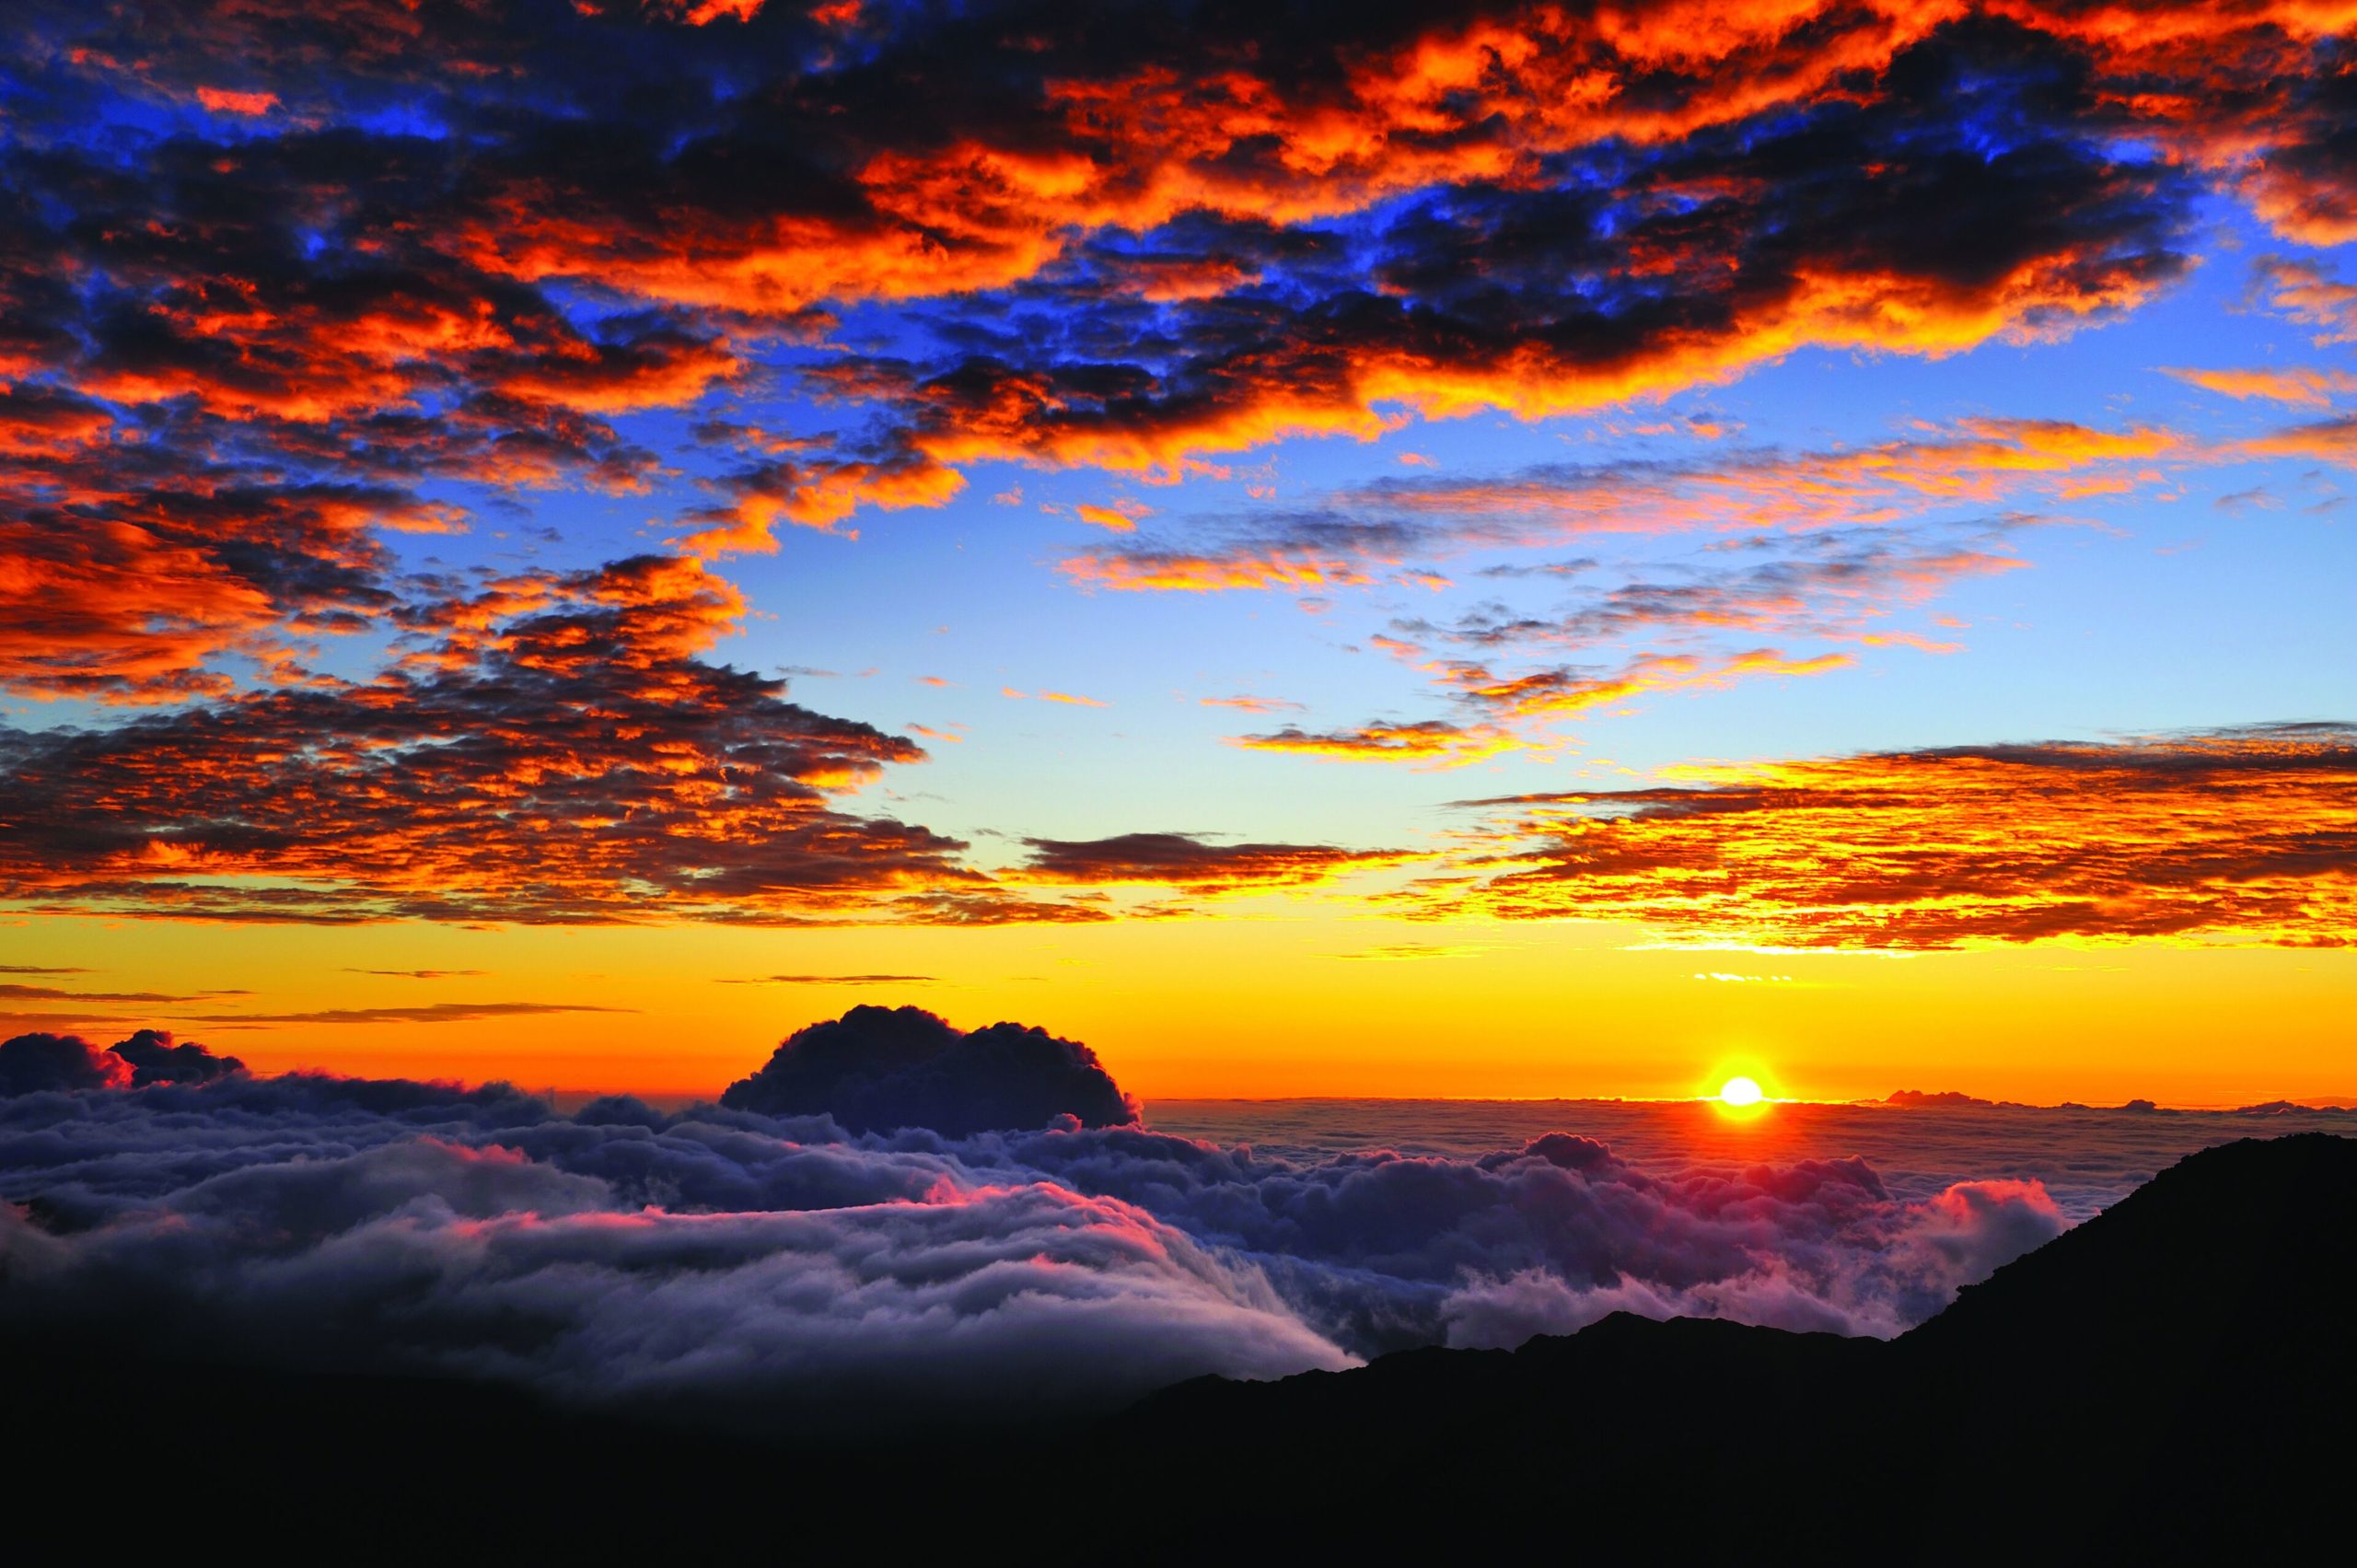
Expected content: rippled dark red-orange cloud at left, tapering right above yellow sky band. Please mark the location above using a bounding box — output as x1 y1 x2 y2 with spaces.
0 556 1103 924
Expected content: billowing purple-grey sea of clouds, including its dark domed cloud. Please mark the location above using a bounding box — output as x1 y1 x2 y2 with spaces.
0 1009 2253 1431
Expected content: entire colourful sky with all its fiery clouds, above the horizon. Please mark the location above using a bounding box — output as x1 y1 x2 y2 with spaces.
0 0 2357 1104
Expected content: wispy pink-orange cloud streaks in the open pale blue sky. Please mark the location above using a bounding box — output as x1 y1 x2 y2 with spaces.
1063 434 2121 766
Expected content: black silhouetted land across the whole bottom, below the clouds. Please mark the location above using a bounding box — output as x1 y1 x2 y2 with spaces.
0 1134 2357 1563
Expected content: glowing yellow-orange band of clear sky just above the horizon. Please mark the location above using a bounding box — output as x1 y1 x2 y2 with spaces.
9 900 2357 1104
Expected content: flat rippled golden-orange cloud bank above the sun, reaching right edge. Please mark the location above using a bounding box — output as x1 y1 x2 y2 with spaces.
1402 724 2357 950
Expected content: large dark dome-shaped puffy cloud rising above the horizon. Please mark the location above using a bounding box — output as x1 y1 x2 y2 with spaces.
721 1007 1138 1136
